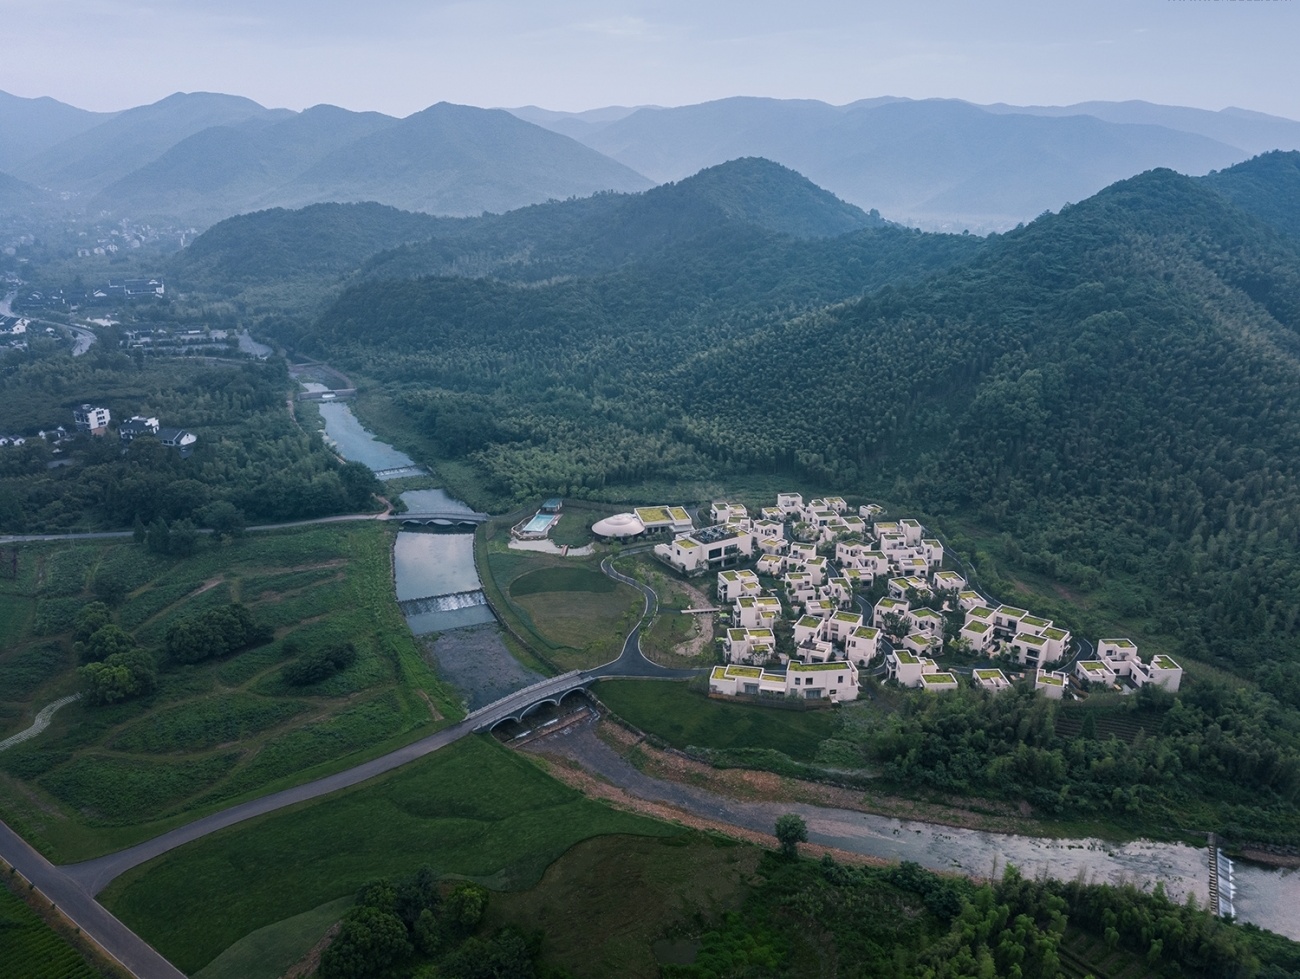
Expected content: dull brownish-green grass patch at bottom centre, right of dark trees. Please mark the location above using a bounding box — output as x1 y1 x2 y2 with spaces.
486 833 762 979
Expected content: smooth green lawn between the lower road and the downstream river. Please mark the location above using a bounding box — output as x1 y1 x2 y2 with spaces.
100 737 680 972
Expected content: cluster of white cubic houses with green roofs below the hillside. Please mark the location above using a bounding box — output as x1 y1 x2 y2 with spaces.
593 493 1182 701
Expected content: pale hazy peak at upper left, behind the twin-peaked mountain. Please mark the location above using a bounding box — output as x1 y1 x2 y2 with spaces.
14 92 287 194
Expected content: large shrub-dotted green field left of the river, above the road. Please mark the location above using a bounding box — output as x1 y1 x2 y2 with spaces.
0 523 460 861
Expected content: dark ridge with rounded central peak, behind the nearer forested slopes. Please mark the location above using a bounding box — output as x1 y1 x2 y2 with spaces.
174 159 883 293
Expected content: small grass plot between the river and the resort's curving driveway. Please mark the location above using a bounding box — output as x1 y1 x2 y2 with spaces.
476 527 644 671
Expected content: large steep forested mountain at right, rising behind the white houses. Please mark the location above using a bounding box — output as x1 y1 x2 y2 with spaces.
680 170 1300 670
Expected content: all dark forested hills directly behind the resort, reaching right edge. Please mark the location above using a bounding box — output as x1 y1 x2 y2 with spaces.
292 162 1300 681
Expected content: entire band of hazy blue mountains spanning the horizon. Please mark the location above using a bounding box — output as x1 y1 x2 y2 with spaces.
0 92 1300 231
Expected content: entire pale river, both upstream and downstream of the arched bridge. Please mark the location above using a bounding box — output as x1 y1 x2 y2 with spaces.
306 397 1300 941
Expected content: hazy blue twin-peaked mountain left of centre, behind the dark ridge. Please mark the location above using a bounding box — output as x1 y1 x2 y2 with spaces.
95 103 650 225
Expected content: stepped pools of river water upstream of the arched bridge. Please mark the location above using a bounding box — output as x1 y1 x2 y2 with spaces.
312 397 495 636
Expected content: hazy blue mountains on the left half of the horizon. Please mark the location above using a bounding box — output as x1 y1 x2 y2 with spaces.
0 92 653 225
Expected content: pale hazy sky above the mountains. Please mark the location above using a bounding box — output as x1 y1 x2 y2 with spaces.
0 0 1300 118
